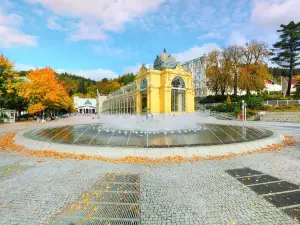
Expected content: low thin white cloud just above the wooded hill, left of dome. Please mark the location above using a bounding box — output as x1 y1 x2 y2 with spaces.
55 68 119 81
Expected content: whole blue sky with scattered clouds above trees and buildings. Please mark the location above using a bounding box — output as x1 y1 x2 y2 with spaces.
0 0 300 80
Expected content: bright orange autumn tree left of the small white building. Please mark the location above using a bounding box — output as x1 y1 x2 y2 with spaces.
16 67 74 114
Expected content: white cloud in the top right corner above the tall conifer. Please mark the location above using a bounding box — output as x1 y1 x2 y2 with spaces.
251 0 300 31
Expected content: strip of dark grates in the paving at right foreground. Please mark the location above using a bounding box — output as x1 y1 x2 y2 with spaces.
225 168 300 222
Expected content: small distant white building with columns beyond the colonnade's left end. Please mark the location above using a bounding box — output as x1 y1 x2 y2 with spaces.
74 96 97 114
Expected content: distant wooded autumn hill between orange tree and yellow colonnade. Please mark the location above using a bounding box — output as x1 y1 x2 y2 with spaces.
19 71 136 98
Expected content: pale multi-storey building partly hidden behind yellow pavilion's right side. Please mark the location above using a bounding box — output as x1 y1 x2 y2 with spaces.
182 55 207 97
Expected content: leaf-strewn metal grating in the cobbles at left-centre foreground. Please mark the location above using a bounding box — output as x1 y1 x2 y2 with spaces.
51 173 140 225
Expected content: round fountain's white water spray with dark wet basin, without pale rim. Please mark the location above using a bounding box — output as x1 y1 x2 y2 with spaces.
25 113 273 148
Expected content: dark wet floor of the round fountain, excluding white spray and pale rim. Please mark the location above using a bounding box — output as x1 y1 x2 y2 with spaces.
24 124 273 148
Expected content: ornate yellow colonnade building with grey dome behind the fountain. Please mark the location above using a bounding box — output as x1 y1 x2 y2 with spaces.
102 51 194 114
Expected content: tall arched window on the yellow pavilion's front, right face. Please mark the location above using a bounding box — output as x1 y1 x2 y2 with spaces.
171 77 185 112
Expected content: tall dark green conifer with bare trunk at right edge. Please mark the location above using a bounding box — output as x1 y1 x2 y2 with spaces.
271 21 300 96
